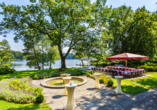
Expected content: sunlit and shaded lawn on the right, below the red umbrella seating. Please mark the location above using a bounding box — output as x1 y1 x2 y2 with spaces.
113 72 157 95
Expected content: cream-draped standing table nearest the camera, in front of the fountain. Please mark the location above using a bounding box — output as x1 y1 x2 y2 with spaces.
65 84 77 110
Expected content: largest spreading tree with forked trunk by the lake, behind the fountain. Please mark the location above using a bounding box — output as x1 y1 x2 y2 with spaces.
0 0 110 68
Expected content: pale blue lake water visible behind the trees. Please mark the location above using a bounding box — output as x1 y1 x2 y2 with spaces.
12 59 87 71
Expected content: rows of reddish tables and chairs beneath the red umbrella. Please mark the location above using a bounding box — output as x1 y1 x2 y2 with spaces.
92 66 145 78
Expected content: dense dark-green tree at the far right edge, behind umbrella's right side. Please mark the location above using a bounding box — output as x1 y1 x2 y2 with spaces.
128 7 157 59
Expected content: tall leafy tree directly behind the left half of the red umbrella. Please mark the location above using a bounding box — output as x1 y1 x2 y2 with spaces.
108 5 134 55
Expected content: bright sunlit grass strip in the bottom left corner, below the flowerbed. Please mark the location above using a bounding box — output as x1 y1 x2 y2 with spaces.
0 100 50 110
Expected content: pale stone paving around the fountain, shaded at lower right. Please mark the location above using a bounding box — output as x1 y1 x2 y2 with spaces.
33 77 157 110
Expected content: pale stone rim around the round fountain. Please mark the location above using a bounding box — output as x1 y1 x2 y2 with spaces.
40 76 87 88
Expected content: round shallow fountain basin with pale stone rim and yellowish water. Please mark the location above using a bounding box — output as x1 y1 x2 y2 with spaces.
40 76 87 88
